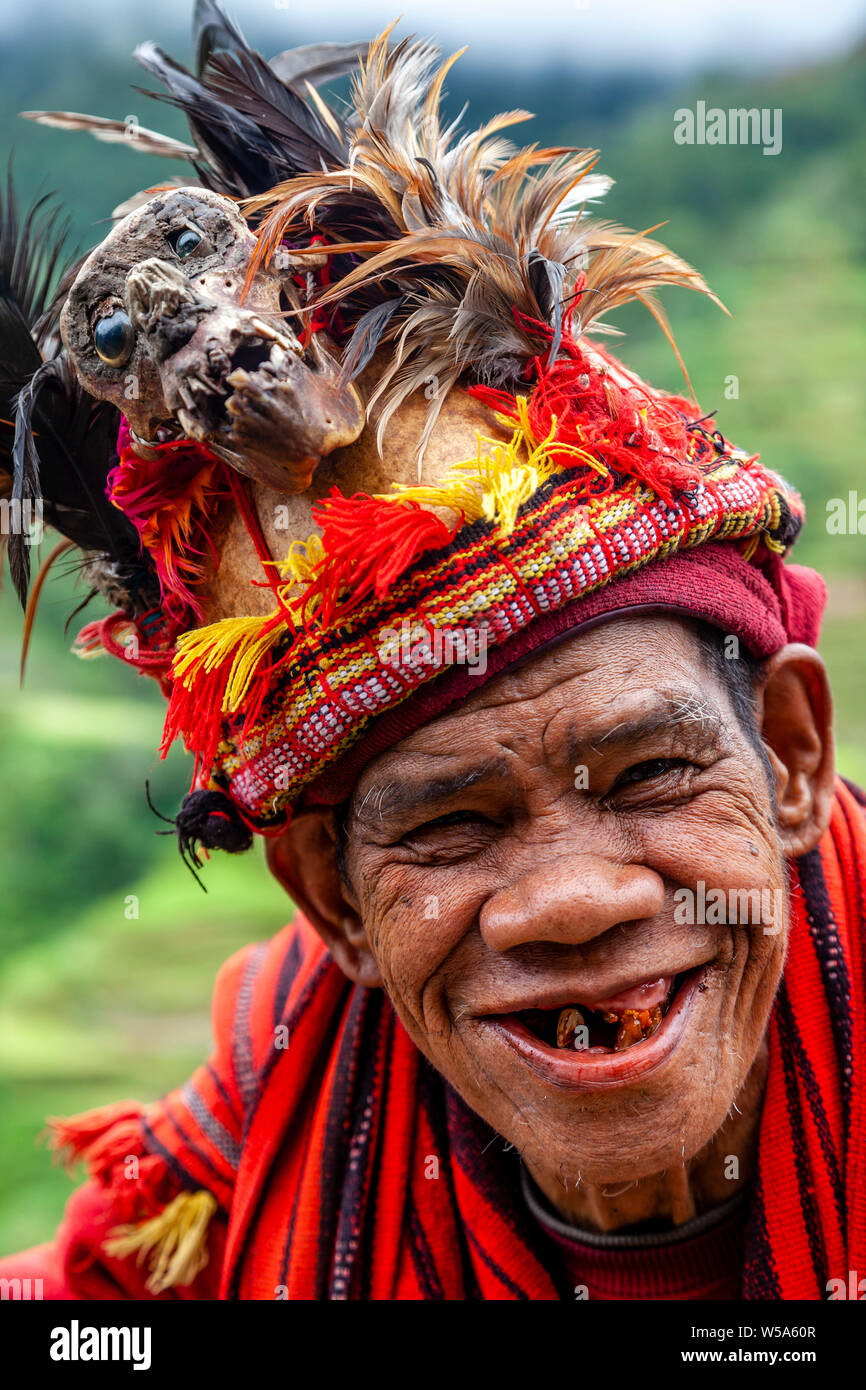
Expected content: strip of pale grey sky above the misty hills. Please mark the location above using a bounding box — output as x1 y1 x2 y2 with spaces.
0 0 866 68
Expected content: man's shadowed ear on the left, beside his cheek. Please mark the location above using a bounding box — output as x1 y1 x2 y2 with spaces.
265 806 382 990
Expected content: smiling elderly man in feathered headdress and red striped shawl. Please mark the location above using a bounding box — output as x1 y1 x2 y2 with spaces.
3 10 866 1300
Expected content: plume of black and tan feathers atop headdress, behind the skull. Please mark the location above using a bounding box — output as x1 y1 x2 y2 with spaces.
25 0 717 452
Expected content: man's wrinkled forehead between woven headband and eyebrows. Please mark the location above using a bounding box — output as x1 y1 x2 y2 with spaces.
335 609 735 806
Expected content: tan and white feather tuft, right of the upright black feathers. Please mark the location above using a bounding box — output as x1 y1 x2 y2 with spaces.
245 21 714 448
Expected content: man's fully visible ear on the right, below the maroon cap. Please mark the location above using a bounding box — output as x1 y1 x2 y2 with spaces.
759 642 835 859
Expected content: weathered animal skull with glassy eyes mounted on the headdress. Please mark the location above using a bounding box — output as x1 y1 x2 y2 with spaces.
60 188 364 493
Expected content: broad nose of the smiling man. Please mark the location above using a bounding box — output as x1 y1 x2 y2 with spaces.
480 853 664 951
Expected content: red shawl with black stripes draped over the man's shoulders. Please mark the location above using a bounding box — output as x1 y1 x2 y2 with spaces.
0 781 866 1300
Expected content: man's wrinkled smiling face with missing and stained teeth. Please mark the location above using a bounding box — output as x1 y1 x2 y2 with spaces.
346 616 787 1184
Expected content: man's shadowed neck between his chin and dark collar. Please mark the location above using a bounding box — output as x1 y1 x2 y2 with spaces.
527 1040 767 1232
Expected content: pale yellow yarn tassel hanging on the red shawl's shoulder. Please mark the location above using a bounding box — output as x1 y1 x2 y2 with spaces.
104 1190 217 1294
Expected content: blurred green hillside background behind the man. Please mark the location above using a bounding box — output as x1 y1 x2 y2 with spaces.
0 4 866 1252
